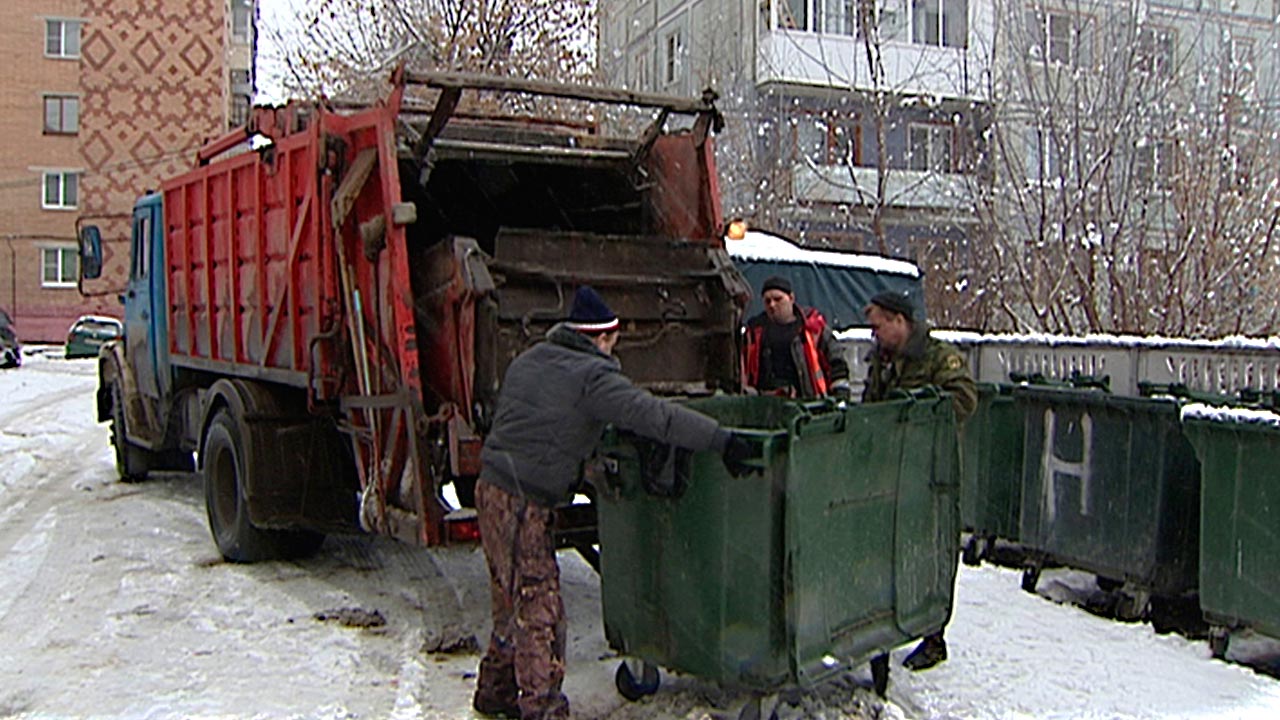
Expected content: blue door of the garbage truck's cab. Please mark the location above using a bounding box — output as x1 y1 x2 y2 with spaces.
124 195 164 398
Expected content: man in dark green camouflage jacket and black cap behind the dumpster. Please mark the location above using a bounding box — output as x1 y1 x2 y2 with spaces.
863 291 978 670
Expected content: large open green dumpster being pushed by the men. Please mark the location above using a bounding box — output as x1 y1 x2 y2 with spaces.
596 392 959 697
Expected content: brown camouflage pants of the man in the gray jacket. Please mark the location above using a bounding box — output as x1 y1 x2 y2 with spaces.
476 482 568 720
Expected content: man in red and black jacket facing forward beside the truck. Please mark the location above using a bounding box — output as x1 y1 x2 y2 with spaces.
742 275 850 397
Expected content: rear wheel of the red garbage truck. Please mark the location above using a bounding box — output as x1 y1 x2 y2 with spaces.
200 409 324 562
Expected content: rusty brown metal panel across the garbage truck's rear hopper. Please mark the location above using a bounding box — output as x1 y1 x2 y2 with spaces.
490 231 745 393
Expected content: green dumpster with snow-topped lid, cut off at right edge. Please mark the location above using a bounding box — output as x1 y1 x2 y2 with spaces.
1183 405 1280 657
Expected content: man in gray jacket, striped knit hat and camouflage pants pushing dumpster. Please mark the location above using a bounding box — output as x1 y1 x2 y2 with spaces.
472 286 751 720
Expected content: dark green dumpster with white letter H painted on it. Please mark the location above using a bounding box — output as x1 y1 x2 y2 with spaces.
1014 386 1199 607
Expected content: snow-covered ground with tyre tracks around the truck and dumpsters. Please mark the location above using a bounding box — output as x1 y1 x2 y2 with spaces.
0 355 1280 720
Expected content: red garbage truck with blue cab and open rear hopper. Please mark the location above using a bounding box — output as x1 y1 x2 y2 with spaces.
79 69 749 561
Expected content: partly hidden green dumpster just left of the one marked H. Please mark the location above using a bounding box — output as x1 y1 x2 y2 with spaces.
960 383 1024 556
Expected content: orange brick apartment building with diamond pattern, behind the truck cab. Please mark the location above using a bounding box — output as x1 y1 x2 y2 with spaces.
0 0 256 343
